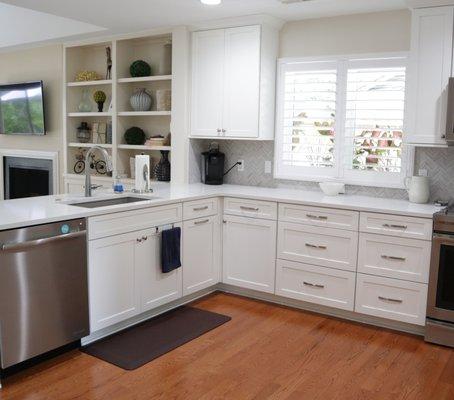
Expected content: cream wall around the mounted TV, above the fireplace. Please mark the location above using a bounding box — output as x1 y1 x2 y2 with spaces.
0 45 63 190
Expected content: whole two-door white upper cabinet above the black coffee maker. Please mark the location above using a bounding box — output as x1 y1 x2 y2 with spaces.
190 25 278 140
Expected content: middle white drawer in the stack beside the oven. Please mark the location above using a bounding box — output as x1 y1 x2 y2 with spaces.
358 233 431 283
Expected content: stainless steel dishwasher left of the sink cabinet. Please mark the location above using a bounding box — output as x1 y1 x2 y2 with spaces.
0 219 89 369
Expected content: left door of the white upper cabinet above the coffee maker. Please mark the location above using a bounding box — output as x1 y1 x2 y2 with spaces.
191 29 225 137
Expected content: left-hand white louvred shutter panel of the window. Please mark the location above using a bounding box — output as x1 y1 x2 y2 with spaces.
278 62 337 176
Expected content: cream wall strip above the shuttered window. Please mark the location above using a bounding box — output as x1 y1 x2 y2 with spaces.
280 10 411 57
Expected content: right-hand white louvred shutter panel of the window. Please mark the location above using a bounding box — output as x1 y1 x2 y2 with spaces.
344 59 406 183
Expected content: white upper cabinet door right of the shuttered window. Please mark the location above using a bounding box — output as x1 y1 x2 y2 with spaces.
406 7 454 145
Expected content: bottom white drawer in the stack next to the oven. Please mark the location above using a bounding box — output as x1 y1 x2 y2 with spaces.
355 274 427 325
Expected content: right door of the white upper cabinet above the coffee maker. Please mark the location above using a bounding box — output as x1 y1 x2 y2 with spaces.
222 26 260 138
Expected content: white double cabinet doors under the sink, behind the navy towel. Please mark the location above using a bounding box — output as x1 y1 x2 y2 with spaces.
89 224 182 332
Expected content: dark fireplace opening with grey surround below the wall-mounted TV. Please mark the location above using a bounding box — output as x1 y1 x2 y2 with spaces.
3 157 53 200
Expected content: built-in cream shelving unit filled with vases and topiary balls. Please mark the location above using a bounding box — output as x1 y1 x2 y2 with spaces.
63 30 175 191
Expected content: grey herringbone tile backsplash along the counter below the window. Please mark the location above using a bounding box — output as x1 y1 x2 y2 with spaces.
189 139 454 200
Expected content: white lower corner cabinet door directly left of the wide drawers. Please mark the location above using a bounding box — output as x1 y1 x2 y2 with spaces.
223 215 276 293
